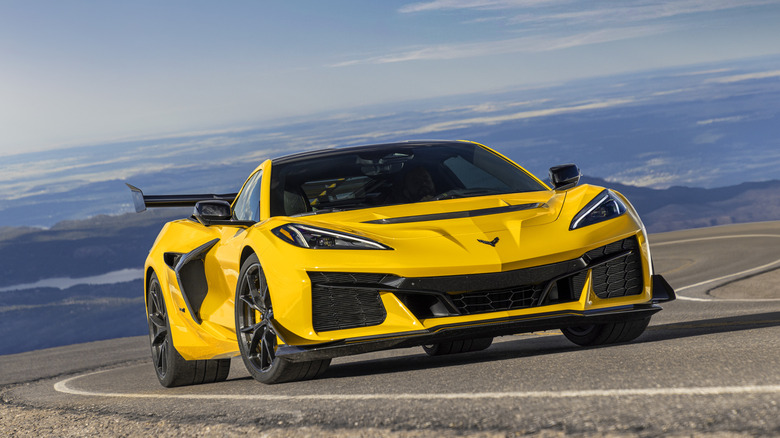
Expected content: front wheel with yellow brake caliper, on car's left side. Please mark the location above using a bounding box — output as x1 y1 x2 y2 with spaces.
235 254 330 384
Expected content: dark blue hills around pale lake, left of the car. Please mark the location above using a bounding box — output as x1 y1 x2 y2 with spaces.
0 210 177 354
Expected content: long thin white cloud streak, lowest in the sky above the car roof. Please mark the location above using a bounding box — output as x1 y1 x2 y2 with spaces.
331 26 669 67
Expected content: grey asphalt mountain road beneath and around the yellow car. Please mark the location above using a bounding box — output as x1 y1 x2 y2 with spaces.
0 222 780 436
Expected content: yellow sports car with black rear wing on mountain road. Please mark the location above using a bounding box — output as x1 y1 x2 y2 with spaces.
130 141 675 386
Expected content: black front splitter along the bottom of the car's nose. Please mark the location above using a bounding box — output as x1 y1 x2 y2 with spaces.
276 275 676 362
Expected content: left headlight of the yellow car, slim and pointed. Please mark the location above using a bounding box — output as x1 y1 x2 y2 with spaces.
271 224 393 249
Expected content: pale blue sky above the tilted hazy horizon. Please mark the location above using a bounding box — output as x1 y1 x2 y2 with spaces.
0 0 780 159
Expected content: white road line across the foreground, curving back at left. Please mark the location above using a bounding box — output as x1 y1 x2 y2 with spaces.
54 370 780 401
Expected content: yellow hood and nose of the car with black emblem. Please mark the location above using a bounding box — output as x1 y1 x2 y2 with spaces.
264 185 638 277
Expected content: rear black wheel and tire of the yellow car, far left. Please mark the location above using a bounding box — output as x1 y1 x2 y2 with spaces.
146 273 230 388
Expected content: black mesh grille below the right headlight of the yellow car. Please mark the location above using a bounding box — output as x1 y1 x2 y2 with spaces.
585 237 643 298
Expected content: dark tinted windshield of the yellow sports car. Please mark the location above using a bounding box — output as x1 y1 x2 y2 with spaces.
270 143 546 216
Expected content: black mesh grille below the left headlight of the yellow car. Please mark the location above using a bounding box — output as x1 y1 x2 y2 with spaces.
309 272 387 332
